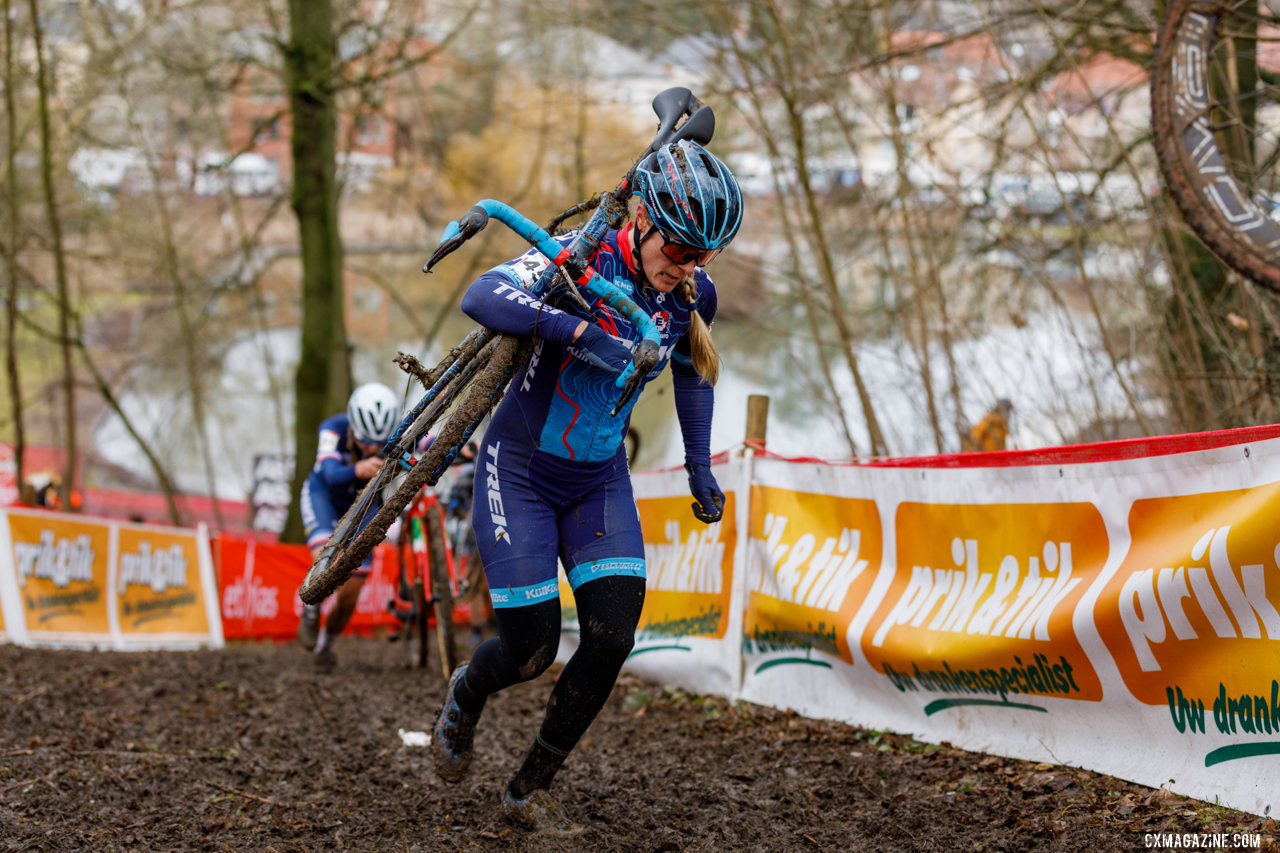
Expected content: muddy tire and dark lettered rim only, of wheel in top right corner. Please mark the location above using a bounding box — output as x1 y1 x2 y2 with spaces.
1151 0 1280 292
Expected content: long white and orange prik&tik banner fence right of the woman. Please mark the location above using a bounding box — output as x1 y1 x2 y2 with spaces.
562 428 1280 815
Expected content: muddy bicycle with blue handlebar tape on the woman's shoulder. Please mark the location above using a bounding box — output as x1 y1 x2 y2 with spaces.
298 88 716 605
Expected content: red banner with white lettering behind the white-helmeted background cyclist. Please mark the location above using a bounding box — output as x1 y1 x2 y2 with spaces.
214 535 399 639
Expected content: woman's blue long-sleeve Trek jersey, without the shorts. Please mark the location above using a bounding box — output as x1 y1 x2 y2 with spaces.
462 229 716 464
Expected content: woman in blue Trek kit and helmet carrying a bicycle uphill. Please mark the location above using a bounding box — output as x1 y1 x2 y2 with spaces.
433 141 742 830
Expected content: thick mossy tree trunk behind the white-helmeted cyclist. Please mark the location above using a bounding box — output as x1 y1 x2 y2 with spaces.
282 0 351 542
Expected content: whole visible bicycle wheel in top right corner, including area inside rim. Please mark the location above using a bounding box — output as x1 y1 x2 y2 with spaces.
1151 0 1280 292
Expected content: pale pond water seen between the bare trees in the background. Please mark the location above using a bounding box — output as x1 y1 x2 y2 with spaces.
93 252 1156 500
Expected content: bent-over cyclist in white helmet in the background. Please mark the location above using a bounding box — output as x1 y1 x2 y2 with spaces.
298 382 399 667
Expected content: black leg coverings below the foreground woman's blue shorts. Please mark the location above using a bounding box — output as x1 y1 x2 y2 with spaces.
454 575 644 798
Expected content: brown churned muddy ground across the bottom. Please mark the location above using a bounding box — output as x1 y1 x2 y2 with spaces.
0 638 1275 853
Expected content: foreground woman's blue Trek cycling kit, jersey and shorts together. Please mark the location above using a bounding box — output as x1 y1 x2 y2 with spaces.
462 229 716 608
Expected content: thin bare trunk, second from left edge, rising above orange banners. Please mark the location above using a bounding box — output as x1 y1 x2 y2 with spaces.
28 0 77 511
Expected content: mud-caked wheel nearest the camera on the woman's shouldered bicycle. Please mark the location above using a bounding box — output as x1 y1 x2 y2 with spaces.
298 336 529 605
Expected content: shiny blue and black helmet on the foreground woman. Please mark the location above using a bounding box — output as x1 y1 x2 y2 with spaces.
634 140 742 250
